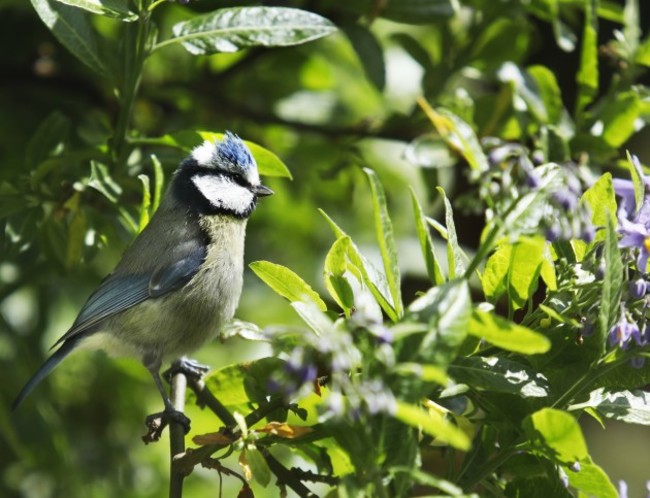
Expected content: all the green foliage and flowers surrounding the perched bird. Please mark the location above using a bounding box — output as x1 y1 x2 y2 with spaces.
0 0 650 498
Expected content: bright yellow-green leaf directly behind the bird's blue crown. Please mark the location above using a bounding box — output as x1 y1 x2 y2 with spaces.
152 130 291 179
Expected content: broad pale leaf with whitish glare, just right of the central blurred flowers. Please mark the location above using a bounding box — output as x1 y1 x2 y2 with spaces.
409 280 472 366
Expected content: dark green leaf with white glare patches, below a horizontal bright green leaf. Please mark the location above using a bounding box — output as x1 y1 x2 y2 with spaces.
448 356 549 398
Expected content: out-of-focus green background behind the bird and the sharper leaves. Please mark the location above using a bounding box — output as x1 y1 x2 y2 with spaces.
0 0 650 498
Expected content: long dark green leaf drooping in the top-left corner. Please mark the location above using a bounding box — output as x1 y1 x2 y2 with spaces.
31 0 111 78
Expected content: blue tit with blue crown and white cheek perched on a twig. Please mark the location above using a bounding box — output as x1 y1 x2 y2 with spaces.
12 131 273 432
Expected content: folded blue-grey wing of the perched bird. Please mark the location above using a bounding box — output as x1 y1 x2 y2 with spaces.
53 241 207 347
